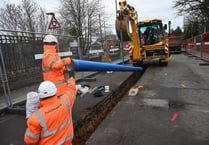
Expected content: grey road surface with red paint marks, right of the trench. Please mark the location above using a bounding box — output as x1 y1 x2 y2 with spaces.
85 54 209 145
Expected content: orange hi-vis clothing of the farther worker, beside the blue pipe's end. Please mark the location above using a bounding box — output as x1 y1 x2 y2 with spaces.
42 45 71 96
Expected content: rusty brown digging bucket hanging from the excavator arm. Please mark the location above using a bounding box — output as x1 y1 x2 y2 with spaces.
115 15 132 41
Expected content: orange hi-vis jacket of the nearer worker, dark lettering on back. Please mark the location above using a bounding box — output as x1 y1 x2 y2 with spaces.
24 77 76 145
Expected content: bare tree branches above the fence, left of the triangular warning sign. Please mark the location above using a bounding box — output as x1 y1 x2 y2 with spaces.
0 0 46 35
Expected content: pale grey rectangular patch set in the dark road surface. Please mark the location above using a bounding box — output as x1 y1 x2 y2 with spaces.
143 99 169 108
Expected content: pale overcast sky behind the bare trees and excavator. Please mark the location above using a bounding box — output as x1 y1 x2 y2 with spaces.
0 0 183 33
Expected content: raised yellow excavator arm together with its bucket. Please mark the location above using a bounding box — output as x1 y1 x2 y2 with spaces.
116 0 142 63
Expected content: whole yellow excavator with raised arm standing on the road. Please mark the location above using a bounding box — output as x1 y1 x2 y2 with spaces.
115 0 170 66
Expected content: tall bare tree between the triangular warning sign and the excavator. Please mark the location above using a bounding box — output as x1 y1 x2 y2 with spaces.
60 0 102 54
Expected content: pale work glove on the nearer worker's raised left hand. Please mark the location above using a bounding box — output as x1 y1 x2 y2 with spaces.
26 92 40 119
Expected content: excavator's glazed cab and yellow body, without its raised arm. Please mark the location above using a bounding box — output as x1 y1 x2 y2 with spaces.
137 19 170 65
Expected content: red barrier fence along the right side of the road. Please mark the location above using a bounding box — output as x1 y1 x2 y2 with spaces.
182 32 209 61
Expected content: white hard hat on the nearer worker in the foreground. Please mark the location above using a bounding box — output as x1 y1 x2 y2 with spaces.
38 81 57 98
